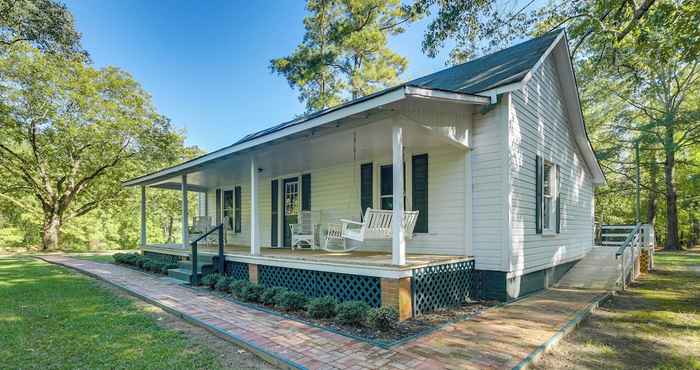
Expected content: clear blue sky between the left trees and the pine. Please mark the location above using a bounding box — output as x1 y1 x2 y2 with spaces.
61 0 504 151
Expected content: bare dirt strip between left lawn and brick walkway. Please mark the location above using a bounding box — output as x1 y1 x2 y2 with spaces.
97 281 277 370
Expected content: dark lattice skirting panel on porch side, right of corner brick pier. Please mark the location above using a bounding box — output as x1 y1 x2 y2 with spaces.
411 260 481 316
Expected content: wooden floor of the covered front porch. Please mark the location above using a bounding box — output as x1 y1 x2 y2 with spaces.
142 244 472 269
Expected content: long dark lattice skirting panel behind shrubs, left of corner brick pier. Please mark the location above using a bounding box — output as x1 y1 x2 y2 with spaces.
258 265 382 307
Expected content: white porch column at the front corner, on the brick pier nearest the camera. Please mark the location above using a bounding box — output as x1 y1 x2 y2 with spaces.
391 126 406 265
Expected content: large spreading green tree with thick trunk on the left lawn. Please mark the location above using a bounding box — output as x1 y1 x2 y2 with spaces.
0 43 190 249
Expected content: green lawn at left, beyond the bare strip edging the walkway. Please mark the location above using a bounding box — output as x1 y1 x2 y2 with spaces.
0 258 221 369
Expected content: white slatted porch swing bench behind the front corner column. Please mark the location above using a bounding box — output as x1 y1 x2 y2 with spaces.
323 208 418 252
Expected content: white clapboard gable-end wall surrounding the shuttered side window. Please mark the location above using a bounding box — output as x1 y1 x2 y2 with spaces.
508 57 593 275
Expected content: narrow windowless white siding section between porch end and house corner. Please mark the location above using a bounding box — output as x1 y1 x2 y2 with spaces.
471 99 508 270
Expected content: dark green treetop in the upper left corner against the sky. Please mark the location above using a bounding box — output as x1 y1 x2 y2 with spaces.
0 0 87 55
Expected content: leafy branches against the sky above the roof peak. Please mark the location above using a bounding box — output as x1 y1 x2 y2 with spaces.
413 0 655 64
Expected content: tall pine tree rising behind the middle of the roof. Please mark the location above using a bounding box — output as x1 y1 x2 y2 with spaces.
270 0 414 111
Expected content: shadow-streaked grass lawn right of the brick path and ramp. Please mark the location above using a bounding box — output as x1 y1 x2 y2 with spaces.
536 248 700 370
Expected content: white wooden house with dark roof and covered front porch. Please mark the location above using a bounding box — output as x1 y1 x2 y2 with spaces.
125 31 605 317
